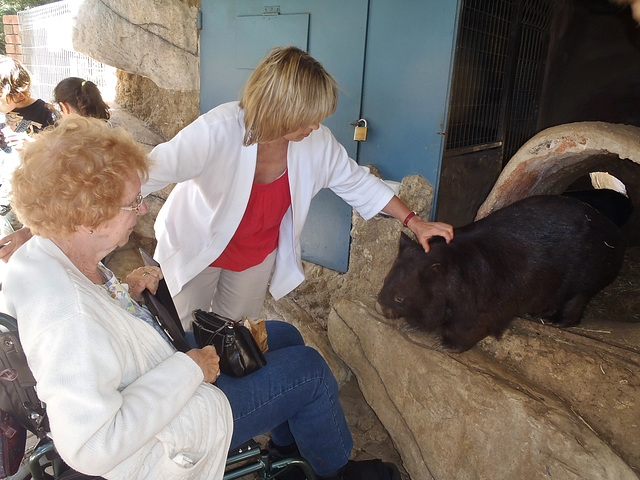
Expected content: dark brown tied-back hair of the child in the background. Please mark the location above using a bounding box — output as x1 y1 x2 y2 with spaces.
53 77 111 120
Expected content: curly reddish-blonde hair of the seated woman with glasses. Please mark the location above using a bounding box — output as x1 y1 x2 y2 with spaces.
11 115 149 238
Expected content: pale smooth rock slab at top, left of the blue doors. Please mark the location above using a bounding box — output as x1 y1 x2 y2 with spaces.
72 0 200 91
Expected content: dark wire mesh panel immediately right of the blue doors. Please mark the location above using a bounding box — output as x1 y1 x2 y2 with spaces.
447 0 556 159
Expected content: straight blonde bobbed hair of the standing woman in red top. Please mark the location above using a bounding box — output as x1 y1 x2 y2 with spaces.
240 47 338 146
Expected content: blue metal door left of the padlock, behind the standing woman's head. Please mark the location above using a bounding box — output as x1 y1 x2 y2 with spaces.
200 0 369 272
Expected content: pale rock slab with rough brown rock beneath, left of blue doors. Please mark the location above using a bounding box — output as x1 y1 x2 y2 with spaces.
72 0 200 140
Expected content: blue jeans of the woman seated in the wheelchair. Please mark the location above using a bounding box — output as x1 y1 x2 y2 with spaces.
194 321 353 475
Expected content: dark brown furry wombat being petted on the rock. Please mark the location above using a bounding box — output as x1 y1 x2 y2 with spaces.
378 195 626 352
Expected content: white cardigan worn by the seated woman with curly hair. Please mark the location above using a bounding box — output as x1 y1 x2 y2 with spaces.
2 236 233 480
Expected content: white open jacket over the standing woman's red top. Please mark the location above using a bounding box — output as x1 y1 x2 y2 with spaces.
142 102 393 299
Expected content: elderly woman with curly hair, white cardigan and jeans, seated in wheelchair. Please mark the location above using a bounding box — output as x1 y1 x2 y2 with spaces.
2 116 399 480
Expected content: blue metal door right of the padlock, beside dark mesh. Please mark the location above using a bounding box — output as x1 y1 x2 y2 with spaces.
358 0 460 202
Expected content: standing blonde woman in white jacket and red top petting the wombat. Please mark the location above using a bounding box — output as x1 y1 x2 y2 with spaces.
142 47 453 330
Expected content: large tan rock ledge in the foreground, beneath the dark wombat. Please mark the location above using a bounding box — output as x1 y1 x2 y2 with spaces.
329 299 640 480
